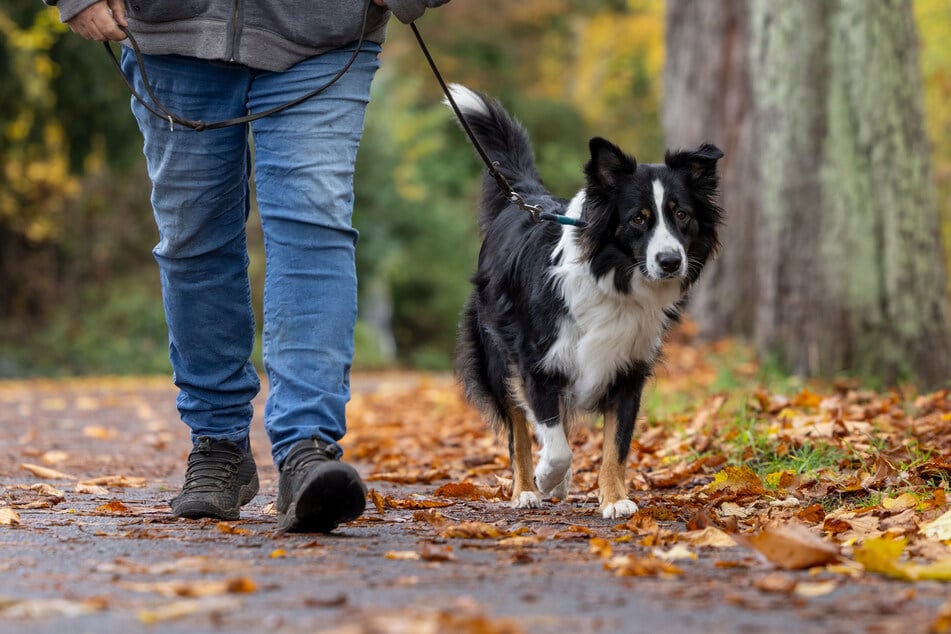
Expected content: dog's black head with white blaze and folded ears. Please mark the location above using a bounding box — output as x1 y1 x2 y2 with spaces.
580 138 723 290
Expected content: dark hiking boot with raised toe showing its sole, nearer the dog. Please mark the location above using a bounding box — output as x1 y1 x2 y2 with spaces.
277 438 367 533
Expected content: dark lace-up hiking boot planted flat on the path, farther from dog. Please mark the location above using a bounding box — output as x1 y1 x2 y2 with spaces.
170 436 258 520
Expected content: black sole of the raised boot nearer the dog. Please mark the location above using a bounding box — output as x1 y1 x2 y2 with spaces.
277 462 367 533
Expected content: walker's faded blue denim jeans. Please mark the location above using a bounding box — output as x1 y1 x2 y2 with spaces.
122 44 380 466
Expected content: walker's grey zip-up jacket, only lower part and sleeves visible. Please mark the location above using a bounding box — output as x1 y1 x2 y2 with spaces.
44 0 449 71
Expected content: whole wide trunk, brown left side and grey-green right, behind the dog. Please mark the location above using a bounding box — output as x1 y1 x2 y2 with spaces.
664 0 951 385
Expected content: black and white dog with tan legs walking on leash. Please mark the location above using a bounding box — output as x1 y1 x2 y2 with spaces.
450 84 724 518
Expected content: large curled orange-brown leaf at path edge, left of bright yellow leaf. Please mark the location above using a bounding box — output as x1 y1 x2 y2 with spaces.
735 522 840 570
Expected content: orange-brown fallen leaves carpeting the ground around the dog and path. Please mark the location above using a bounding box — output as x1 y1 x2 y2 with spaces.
0 328 951 631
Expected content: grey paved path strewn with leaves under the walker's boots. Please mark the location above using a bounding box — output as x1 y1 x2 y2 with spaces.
0 376 948 634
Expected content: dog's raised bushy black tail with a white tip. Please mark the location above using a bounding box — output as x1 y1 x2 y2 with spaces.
447 84 548 231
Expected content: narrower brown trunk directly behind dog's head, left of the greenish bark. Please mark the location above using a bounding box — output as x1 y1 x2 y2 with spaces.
663 0 757 338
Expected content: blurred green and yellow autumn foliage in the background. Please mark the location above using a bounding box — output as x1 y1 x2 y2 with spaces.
0 0 951 388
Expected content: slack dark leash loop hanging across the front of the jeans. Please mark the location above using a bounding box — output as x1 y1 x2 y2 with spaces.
102 0 372 132
